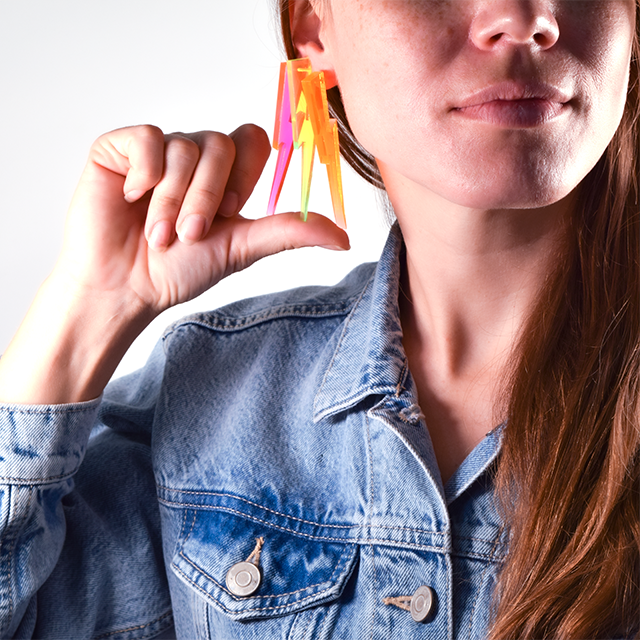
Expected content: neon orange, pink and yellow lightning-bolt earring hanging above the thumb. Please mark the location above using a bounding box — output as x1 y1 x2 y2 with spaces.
267 58 347 229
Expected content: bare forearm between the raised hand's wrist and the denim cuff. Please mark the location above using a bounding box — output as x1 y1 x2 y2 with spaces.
0 277 153 404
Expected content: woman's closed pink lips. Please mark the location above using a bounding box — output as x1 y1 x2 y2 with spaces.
452 82 570 128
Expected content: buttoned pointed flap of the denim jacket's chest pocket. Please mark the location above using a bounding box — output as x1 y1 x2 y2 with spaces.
172 510 357 622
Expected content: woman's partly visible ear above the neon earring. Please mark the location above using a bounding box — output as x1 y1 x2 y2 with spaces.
289 0 338 89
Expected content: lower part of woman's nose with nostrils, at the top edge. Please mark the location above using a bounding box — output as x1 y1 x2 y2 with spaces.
471 0 560 51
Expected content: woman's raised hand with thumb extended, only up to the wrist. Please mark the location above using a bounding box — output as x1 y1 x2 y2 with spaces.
54 125 349 315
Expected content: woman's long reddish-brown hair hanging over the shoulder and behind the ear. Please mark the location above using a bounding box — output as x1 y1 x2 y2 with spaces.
278 0 640 640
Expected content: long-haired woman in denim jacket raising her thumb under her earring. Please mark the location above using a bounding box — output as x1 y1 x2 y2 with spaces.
0 0 640 638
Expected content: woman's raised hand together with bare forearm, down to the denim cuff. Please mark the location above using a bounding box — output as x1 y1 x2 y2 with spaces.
0 125 349 404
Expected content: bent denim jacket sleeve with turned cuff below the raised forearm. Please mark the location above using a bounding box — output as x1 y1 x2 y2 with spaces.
0 342 173 640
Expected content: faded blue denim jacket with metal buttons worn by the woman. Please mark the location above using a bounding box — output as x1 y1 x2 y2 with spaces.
0 227 506 640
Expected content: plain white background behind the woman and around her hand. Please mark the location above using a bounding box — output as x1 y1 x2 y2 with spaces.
0 0 387 373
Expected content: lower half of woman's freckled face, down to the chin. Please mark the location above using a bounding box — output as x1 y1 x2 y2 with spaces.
310 0 635 209
